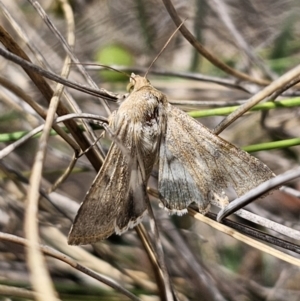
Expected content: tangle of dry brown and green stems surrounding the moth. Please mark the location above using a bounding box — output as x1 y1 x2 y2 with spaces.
0 0 300 301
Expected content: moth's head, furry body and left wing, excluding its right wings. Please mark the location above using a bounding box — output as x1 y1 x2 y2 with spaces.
68 76 167 245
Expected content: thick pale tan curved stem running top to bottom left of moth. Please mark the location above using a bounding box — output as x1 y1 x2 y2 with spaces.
24 3 74 301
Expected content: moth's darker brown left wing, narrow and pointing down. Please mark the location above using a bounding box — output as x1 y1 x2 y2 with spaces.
68 143 148 245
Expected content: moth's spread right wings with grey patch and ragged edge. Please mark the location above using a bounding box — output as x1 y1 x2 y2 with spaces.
159 105 274 214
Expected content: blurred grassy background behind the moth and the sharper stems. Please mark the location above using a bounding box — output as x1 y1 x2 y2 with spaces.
0 0 300 301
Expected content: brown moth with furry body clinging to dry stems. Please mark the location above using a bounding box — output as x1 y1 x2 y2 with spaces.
68 74 274 245
